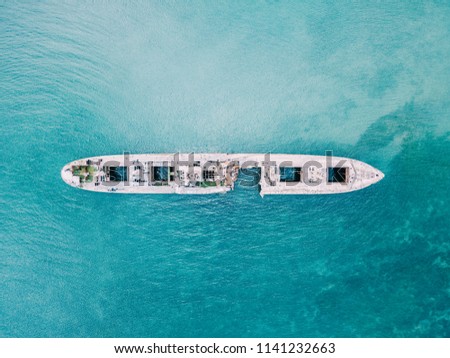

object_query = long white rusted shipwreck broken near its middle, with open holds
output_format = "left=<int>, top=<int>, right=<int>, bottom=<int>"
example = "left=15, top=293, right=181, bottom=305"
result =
left=61, top=153, right=384, bottom=196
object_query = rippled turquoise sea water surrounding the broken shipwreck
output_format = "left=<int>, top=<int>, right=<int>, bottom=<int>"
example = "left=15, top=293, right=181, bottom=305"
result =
left=0, top=1, right=450, bottom=337
